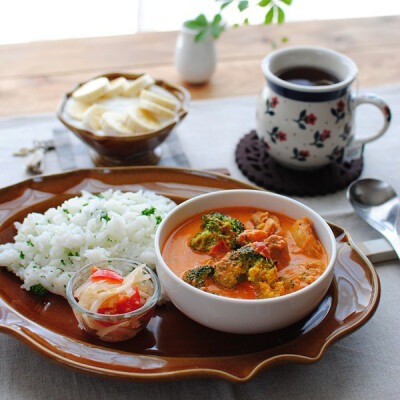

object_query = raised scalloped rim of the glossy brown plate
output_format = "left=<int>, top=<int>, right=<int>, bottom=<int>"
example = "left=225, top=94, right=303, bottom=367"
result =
left=0, top=166, right=381, bottom=382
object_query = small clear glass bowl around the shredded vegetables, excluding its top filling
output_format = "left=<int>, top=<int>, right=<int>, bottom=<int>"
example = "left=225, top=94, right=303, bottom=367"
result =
left=66, top=258, right=160, bottom=342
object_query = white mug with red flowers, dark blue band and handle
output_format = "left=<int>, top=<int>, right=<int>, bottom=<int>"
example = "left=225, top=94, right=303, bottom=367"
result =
left=257, top=46, right=390, bottom=170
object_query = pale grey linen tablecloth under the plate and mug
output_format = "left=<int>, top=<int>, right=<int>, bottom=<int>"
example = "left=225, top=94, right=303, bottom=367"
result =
left=0, top=84, right=400, bottom=400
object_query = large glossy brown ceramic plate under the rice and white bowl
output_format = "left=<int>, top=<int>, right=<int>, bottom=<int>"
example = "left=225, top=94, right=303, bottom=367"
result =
left=0, top=167, right=380, bottom=381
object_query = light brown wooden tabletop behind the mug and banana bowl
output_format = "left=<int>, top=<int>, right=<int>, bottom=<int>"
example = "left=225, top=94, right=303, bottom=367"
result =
left=0, top=16, right=400, bottom=117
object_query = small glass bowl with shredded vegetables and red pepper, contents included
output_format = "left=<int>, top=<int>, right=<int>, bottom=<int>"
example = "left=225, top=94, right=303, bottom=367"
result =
left=66, top=258, right=160, bottom=342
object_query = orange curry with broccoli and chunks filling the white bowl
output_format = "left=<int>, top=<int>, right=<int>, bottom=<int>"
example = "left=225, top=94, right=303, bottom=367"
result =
left=162, top=207, right=328, bottom=299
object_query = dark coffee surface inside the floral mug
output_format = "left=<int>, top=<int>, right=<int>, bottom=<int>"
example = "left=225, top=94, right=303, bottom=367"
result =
left=276, top=67, right=339, bottom=86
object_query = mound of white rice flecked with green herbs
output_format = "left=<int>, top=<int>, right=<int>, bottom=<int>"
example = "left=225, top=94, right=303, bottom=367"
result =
left=0, top=190, right=176, bottom=296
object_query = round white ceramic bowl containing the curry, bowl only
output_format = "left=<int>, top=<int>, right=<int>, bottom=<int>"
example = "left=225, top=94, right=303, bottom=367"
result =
left=155, top=190, right=336, bottom=333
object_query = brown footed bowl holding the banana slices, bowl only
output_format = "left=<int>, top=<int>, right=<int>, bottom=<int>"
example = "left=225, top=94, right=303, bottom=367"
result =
left=57, top=72, right=190, bottom=166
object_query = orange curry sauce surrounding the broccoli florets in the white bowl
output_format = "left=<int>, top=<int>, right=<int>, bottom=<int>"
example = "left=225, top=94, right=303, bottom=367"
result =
left=162, top=207, right=328, bottom=299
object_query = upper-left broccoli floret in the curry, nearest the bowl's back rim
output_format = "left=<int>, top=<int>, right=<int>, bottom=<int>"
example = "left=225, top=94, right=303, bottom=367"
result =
left=190, top=211, right=244, bottom=253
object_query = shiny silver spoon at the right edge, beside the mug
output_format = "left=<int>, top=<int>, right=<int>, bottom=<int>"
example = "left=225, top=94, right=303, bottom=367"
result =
left=347, top=179, right=400, bottom=258
